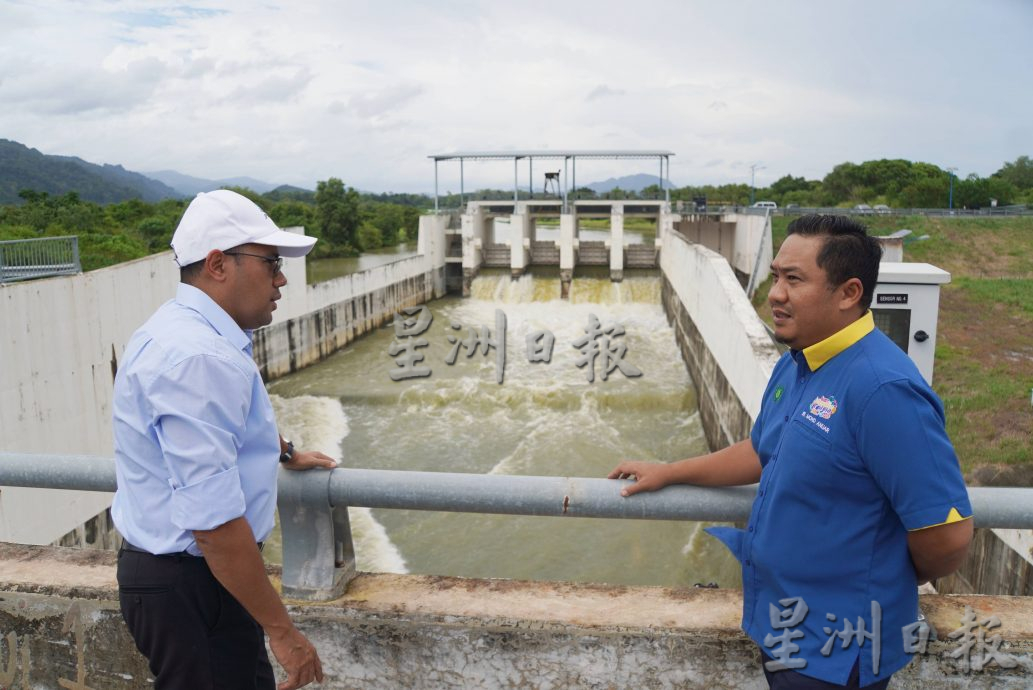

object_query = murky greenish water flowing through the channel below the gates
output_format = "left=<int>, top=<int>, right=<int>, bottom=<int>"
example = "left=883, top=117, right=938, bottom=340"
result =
left=267, top=272, right=740, bottom=587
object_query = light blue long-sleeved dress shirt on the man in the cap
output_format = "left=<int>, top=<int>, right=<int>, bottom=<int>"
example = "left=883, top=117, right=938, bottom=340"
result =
left=112, top=283, right=280, bottom=556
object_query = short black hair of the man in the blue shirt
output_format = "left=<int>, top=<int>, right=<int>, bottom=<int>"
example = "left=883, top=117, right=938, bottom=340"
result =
left=786, top=214, right=882, bottom=311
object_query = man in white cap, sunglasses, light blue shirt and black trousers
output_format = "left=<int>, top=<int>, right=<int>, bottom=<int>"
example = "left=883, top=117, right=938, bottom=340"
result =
left=112, top=190, right=336, bottom=690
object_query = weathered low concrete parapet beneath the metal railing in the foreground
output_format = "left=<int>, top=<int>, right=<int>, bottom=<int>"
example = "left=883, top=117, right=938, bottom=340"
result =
left=0, top=544, right=1033, bottom=690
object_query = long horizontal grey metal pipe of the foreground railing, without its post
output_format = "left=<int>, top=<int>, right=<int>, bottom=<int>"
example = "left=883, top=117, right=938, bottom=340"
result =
left=0, top=452, right=1033, bottom=529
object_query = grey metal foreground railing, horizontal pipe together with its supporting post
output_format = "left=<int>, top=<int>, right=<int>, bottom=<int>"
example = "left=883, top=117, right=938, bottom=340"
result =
left=0, top=452, right=1033, bottom=601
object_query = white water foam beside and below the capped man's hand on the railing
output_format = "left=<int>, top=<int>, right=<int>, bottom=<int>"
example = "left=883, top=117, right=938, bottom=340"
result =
left=270, top=395, right=408, bottom=573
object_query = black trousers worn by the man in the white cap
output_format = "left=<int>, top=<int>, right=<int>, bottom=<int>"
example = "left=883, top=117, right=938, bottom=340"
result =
left=118, top=548, right=276, bottom=690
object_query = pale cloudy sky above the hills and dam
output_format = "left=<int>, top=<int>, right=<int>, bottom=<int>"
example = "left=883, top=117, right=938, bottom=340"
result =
left=0, top=0, right=1033, bottom=192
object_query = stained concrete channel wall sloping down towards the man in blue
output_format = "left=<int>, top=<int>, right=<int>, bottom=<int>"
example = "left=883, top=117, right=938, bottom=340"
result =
left=660, top=232, right=779, bottom=449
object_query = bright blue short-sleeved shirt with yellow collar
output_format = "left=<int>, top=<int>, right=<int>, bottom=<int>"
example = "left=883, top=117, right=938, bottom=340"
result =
left=708, top=312, right=972, bottom=686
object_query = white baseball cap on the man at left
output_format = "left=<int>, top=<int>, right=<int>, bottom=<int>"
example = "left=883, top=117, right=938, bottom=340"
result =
left=171, top=189, right=316, bottom=266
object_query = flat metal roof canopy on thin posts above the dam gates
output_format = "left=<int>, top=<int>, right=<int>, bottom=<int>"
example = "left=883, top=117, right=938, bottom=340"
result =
left=428, top=150, right=675, bottom=211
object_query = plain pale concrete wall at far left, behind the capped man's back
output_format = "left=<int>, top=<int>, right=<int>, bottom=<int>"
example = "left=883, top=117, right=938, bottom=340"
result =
left=0, top=252, right=179, bottom=543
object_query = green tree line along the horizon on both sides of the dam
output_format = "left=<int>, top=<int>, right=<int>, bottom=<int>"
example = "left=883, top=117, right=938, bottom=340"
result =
left=0, top=156, right=1033, bottom=271
